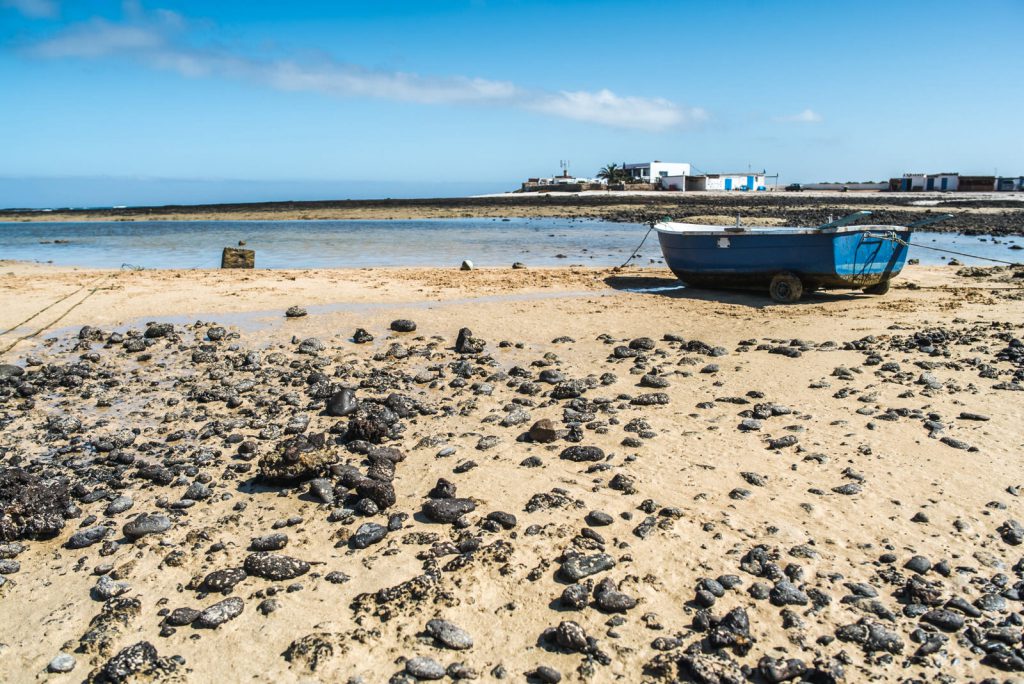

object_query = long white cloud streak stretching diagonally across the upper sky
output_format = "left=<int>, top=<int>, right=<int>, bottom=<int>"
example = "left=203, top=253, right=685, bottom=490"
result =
left=22, top=7, right=704, bottom=131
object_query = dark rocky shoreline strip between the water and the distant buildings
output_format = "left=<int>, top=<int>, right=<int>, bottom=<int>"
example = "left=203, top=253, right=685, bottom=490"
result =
left=6, top=193, right=1024, bottom=237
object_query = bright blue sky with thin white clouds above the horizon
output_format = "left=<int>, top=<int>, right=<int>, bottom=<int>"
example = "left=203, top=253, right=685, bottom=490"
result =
left=0, top=0, right=1024, bottom=206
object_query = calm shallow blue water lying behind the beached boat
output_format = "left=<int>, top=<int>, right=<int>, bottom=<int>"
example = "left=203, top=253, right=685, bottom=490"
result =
left=0, top=218, right=1024, bottom=268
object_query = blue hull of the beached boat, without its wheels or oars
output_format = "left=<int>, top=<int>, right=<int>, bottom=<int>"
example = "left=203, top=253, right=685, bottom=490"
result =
left=657, top=229, right=910, bottom=289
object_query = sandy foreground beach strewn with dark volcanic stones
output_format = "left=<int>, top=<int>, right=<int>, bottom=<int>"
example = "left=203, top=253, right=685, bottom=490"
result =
left=0, top=262, right=1024, bottom=682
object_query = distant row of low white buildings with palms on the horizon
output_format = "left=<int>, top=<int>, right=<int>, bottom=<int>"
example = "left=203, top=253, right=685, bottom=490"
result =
left=518, top=161, right=1024, bottom=193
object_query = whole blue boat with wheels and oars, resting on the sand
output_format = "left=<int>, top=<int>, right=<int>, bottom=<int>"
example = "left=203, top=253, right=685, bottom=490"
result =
left=653, top=211, right=948, bottom=302
